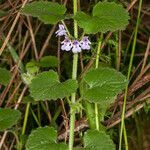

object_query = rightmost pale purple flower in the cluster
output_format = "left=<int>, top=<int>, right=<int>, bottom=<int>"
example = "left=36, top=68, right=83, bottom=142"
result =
left=80, top=36, right=91, bottom=50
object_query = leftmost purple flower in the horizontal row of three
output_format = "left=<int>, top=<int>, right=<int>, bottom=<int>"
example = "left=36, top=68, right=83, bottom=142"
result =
left=61, top=37, right=72, bottom=51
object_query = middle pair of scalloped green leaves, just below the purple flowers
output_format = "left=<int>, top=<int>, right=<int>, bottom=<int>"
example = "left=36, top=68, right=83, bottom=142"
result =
left=29, top=67, right=127, bottom=105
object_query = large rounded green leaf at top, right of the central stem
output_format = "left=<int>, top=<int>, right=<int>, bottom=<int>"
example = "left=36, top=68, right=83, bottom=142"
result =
left=74, top=2, right=129, bottom=33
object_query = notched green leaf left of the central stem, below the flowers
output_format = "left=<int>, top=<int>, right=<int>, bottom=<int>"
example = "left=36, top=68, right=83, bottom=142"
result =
left=29, top=70, right=77, bottom=100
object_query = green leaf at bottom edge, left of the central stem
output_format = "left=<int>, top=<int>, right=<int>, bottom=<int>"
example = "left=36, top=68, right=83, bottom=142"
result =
left=26, top=127, right=67, bottom=150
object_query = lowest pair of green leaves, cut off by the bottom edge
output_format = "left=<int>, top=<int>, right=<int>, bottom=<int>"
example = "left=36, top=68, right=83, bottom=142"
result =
left=26, top=127, right=115, bottom=150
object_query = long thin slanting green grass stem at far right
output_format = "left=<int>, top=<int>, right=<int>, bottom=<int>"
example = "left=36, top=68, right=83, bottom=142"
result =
left=119, top=0, right=142, bottom=150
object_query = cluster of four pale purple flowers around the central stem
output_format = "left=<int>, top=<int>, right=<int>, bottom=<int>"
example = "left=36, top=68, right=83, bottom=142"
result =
left=55, top=24, right=91, bottom=53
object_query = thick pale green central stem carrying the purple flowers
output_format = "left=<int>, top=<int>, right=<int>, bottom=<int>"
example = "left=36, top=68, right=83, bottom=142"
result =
left=69, top=0, right=78, bottom=150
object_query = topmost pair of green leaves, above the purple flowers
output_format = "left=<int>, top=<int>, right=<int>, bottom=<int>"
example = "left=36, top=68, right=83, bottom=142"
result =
left=21, top=1, right=129, bottom=33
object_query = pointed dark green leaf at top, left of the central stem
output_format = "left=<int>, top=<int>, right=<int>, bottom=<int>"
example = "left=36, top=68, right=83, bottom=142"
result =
left=21, top=1, right=66, bottom=24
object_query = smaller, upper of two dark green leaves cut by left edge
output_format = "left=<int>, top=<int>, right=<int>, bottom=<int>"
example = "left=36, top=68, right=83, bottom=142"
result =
left=0, top=68, right=11, bottom=86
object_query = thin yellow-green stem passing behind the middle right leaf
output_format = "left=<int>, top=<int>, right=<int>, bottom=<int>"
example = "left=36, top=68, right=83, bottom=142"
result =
left=95, top=33, right=103, bottom=130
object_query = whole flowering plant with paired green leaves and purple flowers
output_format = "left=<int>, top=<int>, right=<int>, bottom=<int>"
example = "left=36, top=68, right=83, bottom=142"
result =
left=13, top=0, right=129, bottom=150
